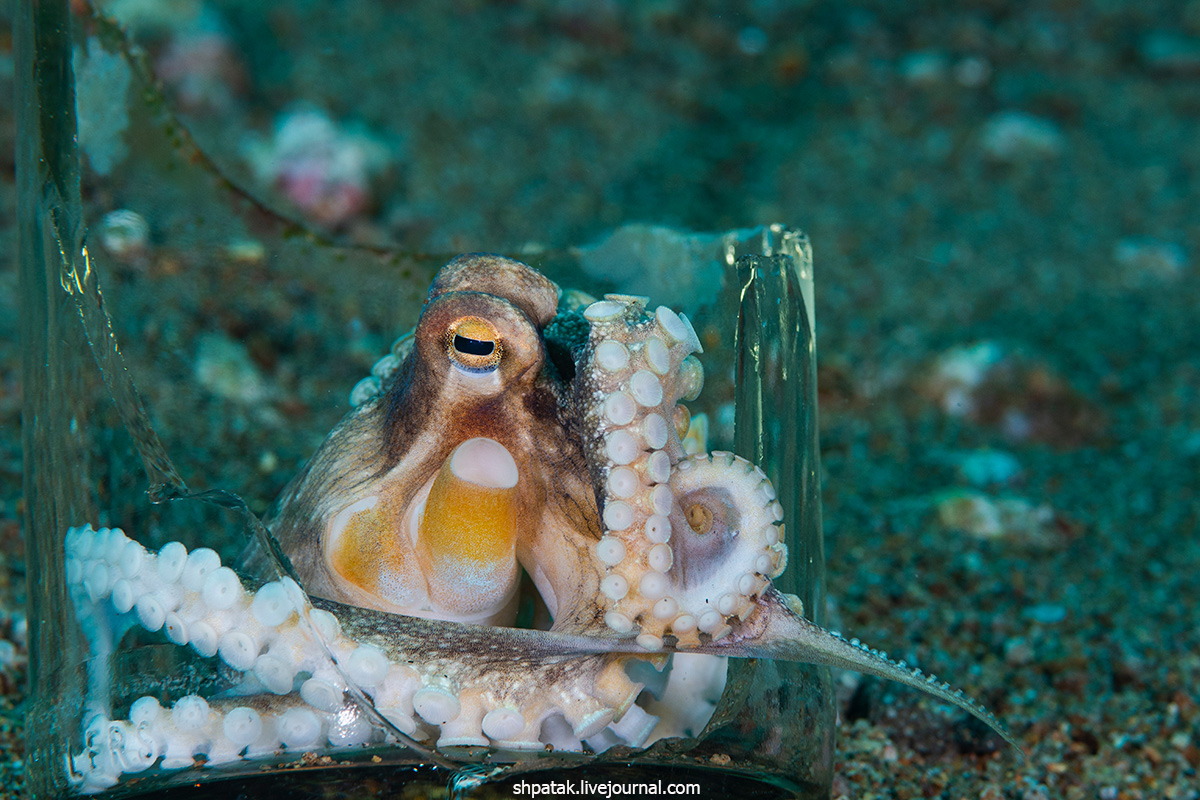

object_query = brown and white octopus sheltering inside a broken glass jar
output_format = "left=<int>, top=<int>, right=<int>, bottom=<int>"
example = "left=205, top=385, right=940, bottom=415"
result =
left=66, top=254, right=1016, bottom=792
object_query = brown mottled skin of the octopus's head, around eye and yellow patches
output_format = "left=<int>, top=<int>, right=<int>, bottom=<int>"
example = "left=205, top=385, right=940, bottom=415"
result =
left=261, top=254, right=600, bottom=630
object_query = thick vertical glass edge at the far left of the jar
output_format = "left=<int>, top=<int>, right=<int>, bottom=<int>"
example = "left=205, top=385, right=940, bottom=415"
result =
left=13, top=0, right=94, bottom=798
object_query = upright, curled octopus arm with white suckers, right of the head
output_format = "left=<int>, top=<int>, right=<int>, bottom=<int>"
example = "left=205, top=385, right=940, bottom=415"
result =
left=580, top=295, right=787, bottom=650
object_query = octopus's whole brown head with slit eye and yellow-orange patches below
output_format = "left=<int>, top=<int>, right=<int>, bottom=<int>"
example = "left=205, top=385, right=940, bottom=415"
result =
left=270, top=255, right=571, bottom=624
